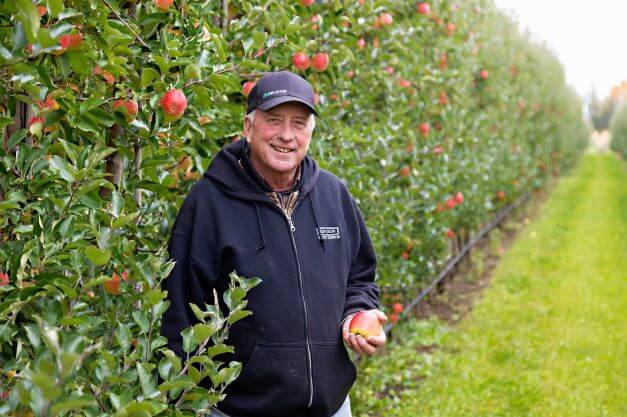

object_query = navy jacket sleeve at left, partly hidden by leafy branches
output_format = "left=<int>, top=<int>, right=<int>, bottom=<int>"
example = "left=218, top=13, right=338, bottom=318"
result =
left=161, top=193, right=215, bottom=359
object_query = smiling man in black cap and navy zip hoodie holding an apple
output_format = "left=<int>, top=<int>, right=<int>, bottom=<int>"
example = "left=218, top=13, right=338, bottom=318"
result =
left=162, top=71, right=387, bottom=417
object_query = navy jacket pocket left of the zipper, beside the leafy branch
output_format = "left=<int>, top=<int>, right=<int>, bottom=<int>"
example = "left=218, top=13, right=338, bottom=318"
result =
left=218, top=342, right=309, bottom=417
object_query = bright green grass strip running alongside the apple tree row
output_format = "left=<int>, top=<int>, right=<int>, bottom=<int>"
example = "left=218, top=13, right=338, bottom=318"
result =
left=351, top=154, right=627, bottom=417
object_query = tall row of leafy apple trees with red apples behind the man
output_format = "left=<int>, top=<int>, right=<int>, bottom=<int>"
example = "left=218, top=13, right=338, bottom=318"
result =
left=0, top=0, right=588, bottom=416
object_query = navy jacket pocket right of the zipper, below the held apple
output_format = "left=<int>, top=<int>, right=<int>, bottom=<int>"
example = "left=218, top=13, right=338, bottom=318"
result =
left=313, top=342, right=357, bottom=415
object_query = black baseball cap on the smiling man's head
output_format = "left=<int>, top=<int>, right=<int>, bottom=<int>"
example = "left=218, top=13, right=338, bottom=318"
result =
left=246, top=71, right=318, bottom=114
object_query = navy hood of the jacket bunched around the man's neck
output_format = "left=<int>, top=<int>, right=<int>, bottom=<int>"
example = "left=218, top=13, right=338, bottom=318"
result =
left=204, top=138, right=320, bottom=202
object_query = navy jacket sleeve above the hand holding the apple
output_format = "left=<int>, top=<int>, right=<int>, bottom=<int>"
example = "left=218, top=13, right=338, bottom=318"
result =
left=343, top=199, right=379, bottom=319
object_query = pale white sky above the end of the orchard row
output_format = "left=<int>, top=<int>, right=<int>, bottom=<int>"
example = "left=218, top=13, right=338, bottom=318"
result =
left=495, top=0, right=627, bottom=99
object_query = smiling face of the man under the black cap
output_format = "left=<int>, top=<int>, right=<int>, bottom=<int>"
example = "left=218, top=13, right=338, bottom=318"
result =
left=244, top=102, right=312, bottom=177
